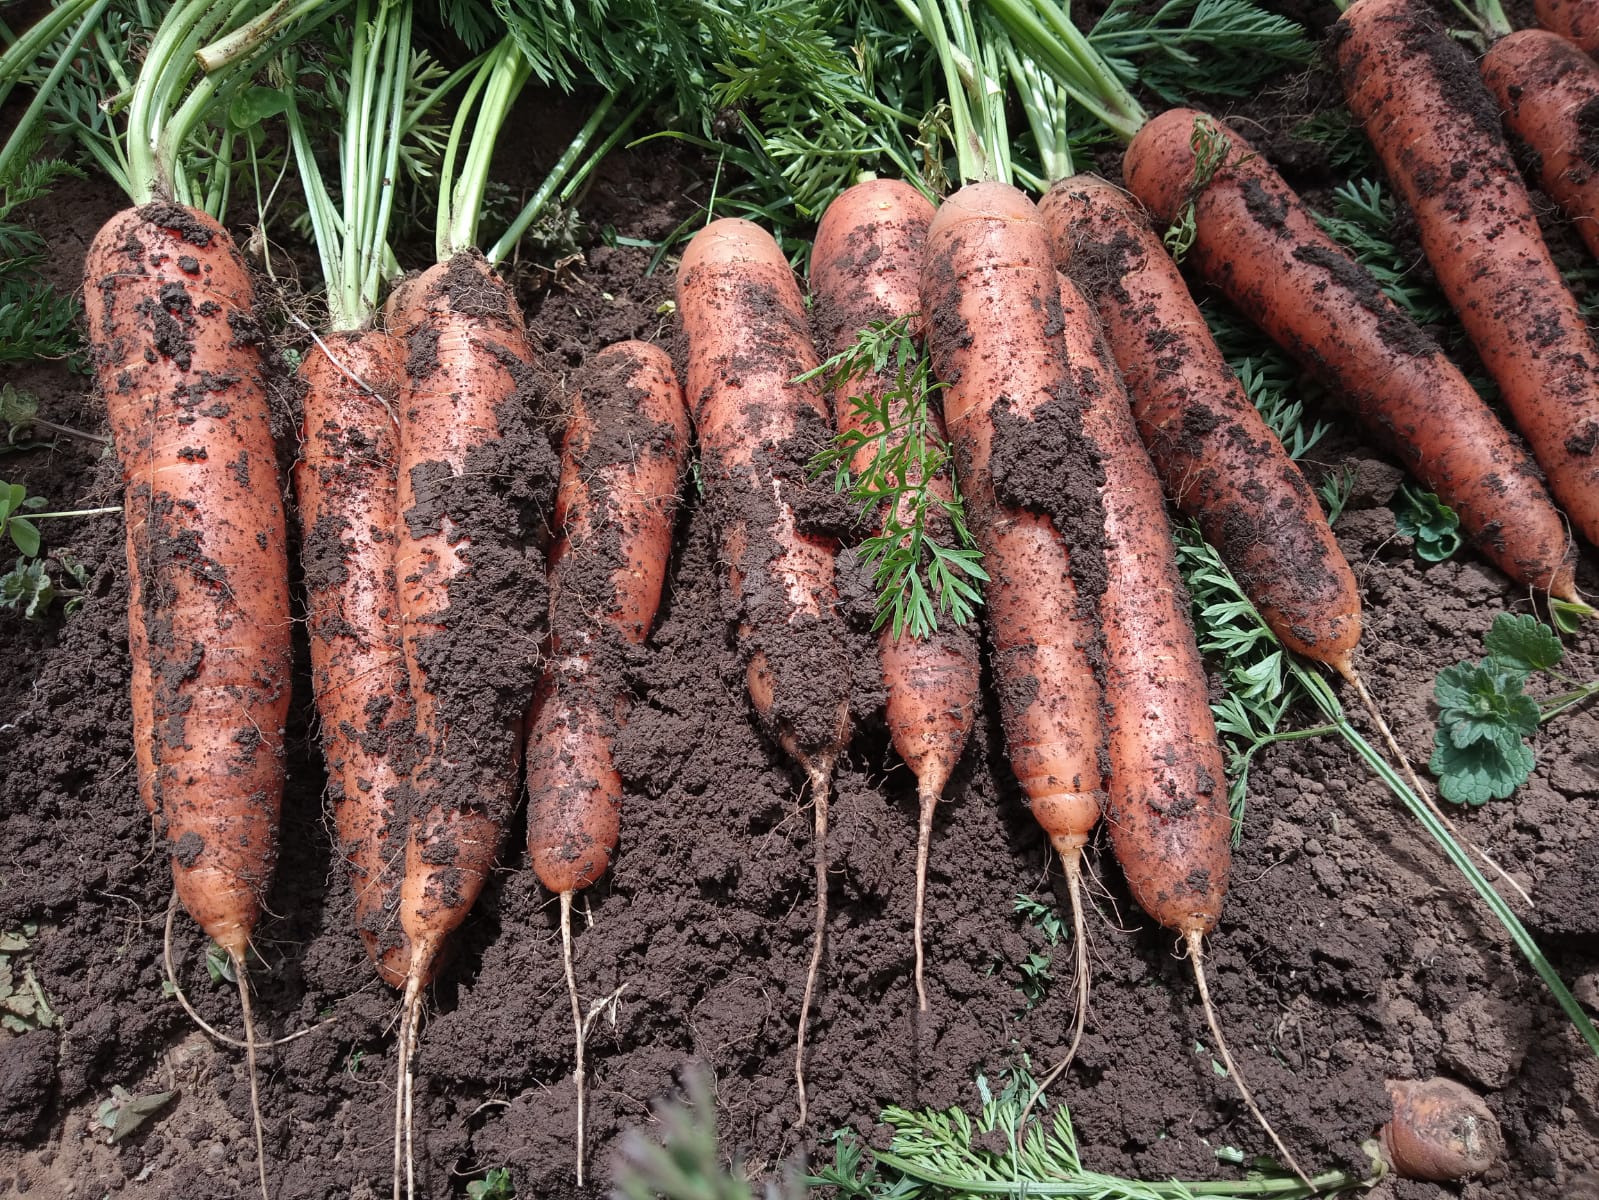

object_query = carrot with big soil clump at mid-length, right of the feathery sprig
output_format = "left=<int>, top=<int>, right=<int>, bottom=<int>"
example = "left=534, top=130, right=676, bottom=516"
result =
left=921, top=182, right=1105, bottom=1081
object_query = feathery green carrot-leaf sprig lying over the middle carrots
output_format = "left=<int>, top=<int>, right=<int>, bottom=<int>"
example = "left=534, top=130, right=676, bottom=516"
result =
left=796, top=317, right=988, bottom=638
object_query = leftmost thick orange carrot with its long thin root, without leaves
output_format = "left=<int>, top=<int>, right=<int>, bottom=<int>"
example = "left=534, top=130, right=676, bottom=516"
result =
left=83, top=202, right=293, bottom=1194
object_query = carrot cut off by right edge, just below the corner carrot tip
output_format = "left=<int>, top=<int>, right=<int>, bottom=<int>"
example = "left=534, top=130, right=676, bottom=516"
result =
left=1481, top=29, right=1599, bottom=265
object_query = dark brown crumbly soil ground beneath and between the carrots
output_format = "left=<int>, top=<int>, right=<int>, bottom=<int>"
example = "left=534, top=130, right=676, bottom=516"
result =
left=0, top=82, right=1599, bottom=1200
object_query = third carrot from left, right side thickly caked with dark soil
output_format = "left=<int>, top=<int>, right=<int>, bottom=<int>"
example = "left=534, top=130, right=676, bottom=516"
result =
left=395, top=251, right=552, bottom=1190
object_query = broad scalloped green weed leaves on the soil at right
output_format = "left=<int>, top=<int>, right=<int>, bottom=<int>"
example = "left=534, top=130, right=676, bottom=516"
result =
left=1428, top=613, right=1599, bottom=805
